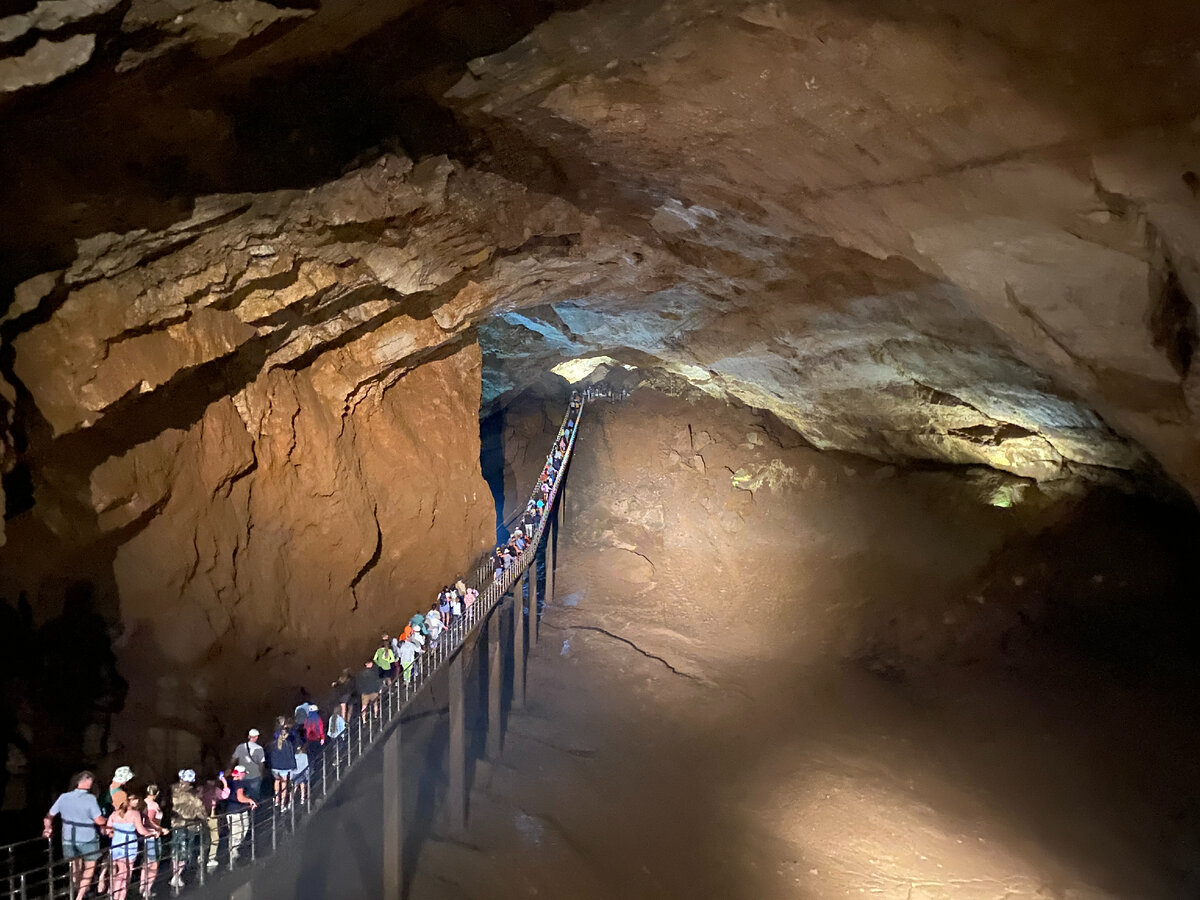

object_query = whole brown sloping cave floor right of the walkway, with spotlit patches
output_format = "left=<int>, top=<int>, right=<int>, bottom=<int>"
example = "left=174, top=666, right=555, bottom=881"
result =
left=410, top=391, right=1200, bottom=900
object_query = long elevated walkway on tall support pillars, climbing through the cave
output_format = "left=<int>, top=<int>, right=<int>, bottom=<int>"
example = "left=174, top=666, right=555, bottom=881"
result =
left=12, top=396, right=584, bottom=900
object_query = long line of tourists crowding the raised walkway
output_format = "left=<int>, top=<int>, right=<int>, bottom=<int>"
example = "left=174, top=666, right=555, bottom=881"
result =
left=42, top=394, right=582, bottom=900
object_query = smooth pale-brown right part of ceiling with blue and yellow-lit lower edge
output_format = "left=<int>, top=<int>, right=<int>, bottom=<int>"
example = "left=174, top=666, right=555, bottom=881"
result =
left=450, top=0, right=1200, bottom=491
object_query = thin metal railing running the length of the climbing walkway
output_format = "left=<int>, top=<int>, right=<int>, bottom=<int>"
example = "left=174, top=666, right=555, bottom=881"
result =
left=12, top=397, right=584, bottom=900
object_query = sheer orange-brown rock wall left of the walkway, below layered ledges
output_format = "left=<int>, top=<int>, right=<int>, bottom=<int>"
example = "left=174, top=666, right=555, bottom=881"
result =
left=4, top=343, right=493, bottom=778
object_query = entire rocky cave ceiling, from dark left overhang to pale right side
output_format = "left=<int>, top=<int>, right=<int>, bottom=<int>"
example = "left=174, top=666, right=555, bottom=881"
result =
left=0, top=0, right=1200, bottom=547
